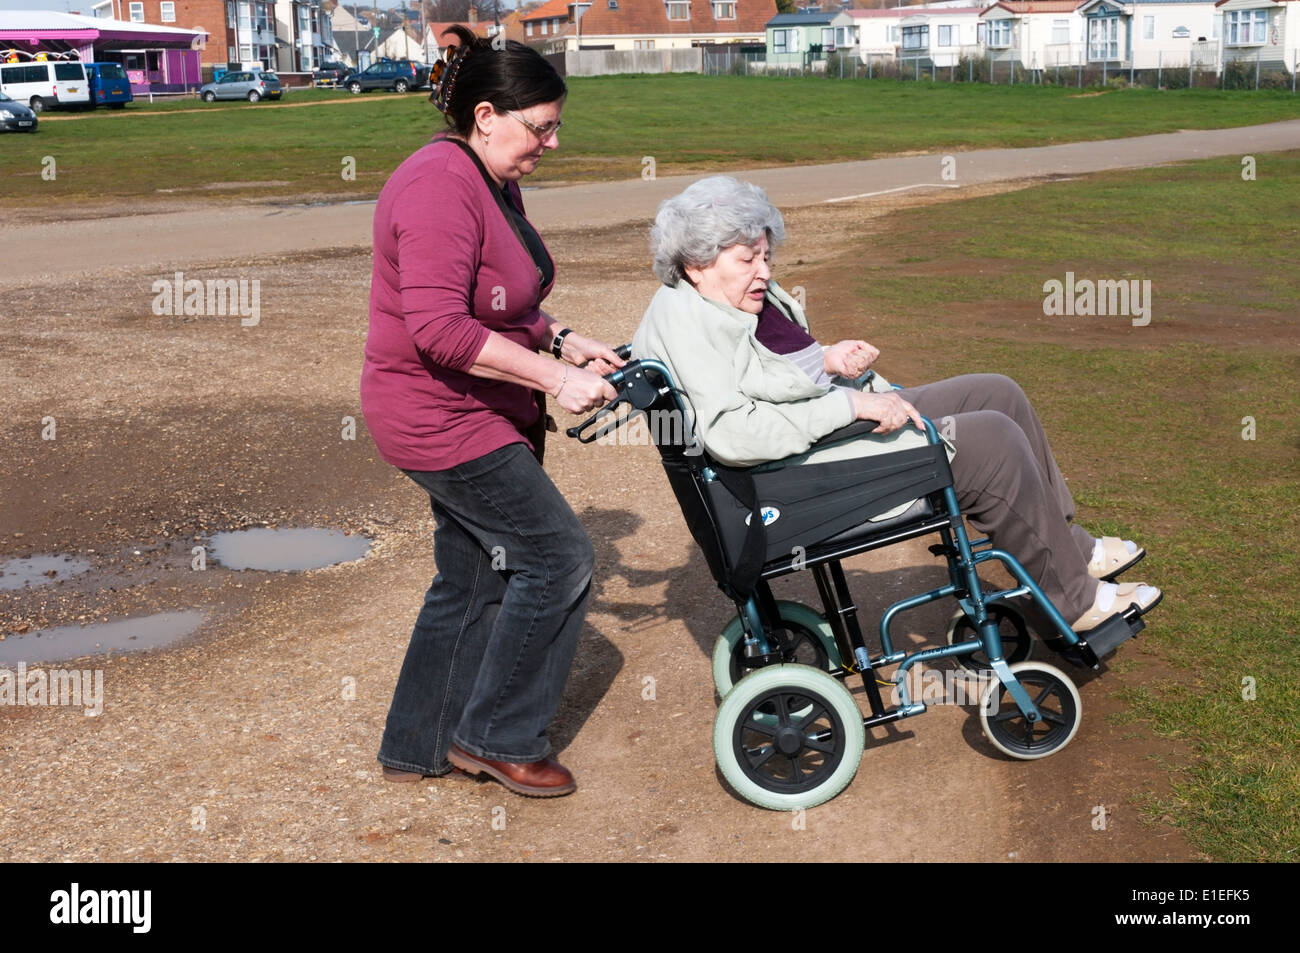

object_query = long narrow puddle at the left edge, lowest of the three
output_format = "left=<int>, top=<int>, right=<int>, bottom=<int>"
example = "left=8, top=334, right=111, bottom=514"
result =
left=0, top=608, right=207, bottom=664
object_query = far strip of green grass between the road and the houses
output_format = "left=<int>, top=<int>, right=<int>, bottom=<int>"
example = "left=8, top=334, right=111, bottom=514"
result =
left=0, top=74, right=1300, bottom=208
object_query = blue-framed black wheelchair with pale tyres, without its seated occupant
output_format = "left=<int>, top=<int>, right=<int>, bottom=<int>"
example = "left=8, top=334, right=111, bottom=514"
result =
left=567, top=346, right=1153, bottom=810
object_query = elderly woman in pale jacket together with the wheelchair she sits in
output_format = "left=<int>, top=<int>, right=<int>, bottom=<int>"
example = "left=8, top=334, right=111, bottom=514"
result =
left=571, top=176, right=1161, bottom=809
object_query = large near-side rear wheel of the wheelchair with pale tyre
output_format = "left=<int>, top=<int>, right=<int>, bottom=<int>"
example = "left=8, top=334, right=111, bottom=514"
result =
left=714, top=664, right=866, bottom=811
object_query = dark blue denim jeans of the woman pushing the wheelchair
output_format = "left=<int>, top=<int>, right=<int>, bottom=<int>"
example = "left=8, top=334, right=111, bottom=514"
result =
left=378, top=443, right=593, bottom=775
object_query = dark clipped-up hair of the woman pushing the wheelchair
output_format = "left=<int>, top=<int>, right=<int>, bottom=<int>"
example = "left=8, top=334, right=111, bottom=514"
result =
left=434, top=23, right=568, bottom=138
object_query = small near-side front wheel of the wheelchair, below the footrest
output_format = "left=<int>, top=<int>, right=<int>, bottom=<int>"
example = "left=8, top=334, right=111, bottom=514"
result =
left=979, top=662, right=1083, bottom=761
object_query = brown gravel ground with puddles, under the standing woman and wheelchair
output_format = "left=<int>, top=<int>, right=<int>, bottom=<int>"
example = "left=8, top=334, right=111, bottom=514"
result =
left=0, top=141, right=1248, bottom=861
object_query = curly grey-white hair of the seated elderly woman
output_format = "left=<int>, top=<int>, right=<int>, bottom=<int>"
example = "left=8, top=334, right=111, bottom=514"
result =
left=650, top=176, right=785, bottom=287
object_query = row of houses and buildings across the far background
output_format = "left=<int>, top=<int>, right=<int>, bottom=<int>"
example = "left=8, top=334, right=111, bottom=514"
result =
left=0, top=0, right=1300, bottom=92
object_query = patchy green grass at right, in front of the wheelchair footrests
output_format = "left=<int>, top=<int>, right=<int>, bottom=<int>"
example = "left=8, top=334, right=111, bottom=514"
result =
left=837, top=153, right=1300, bottom=861
